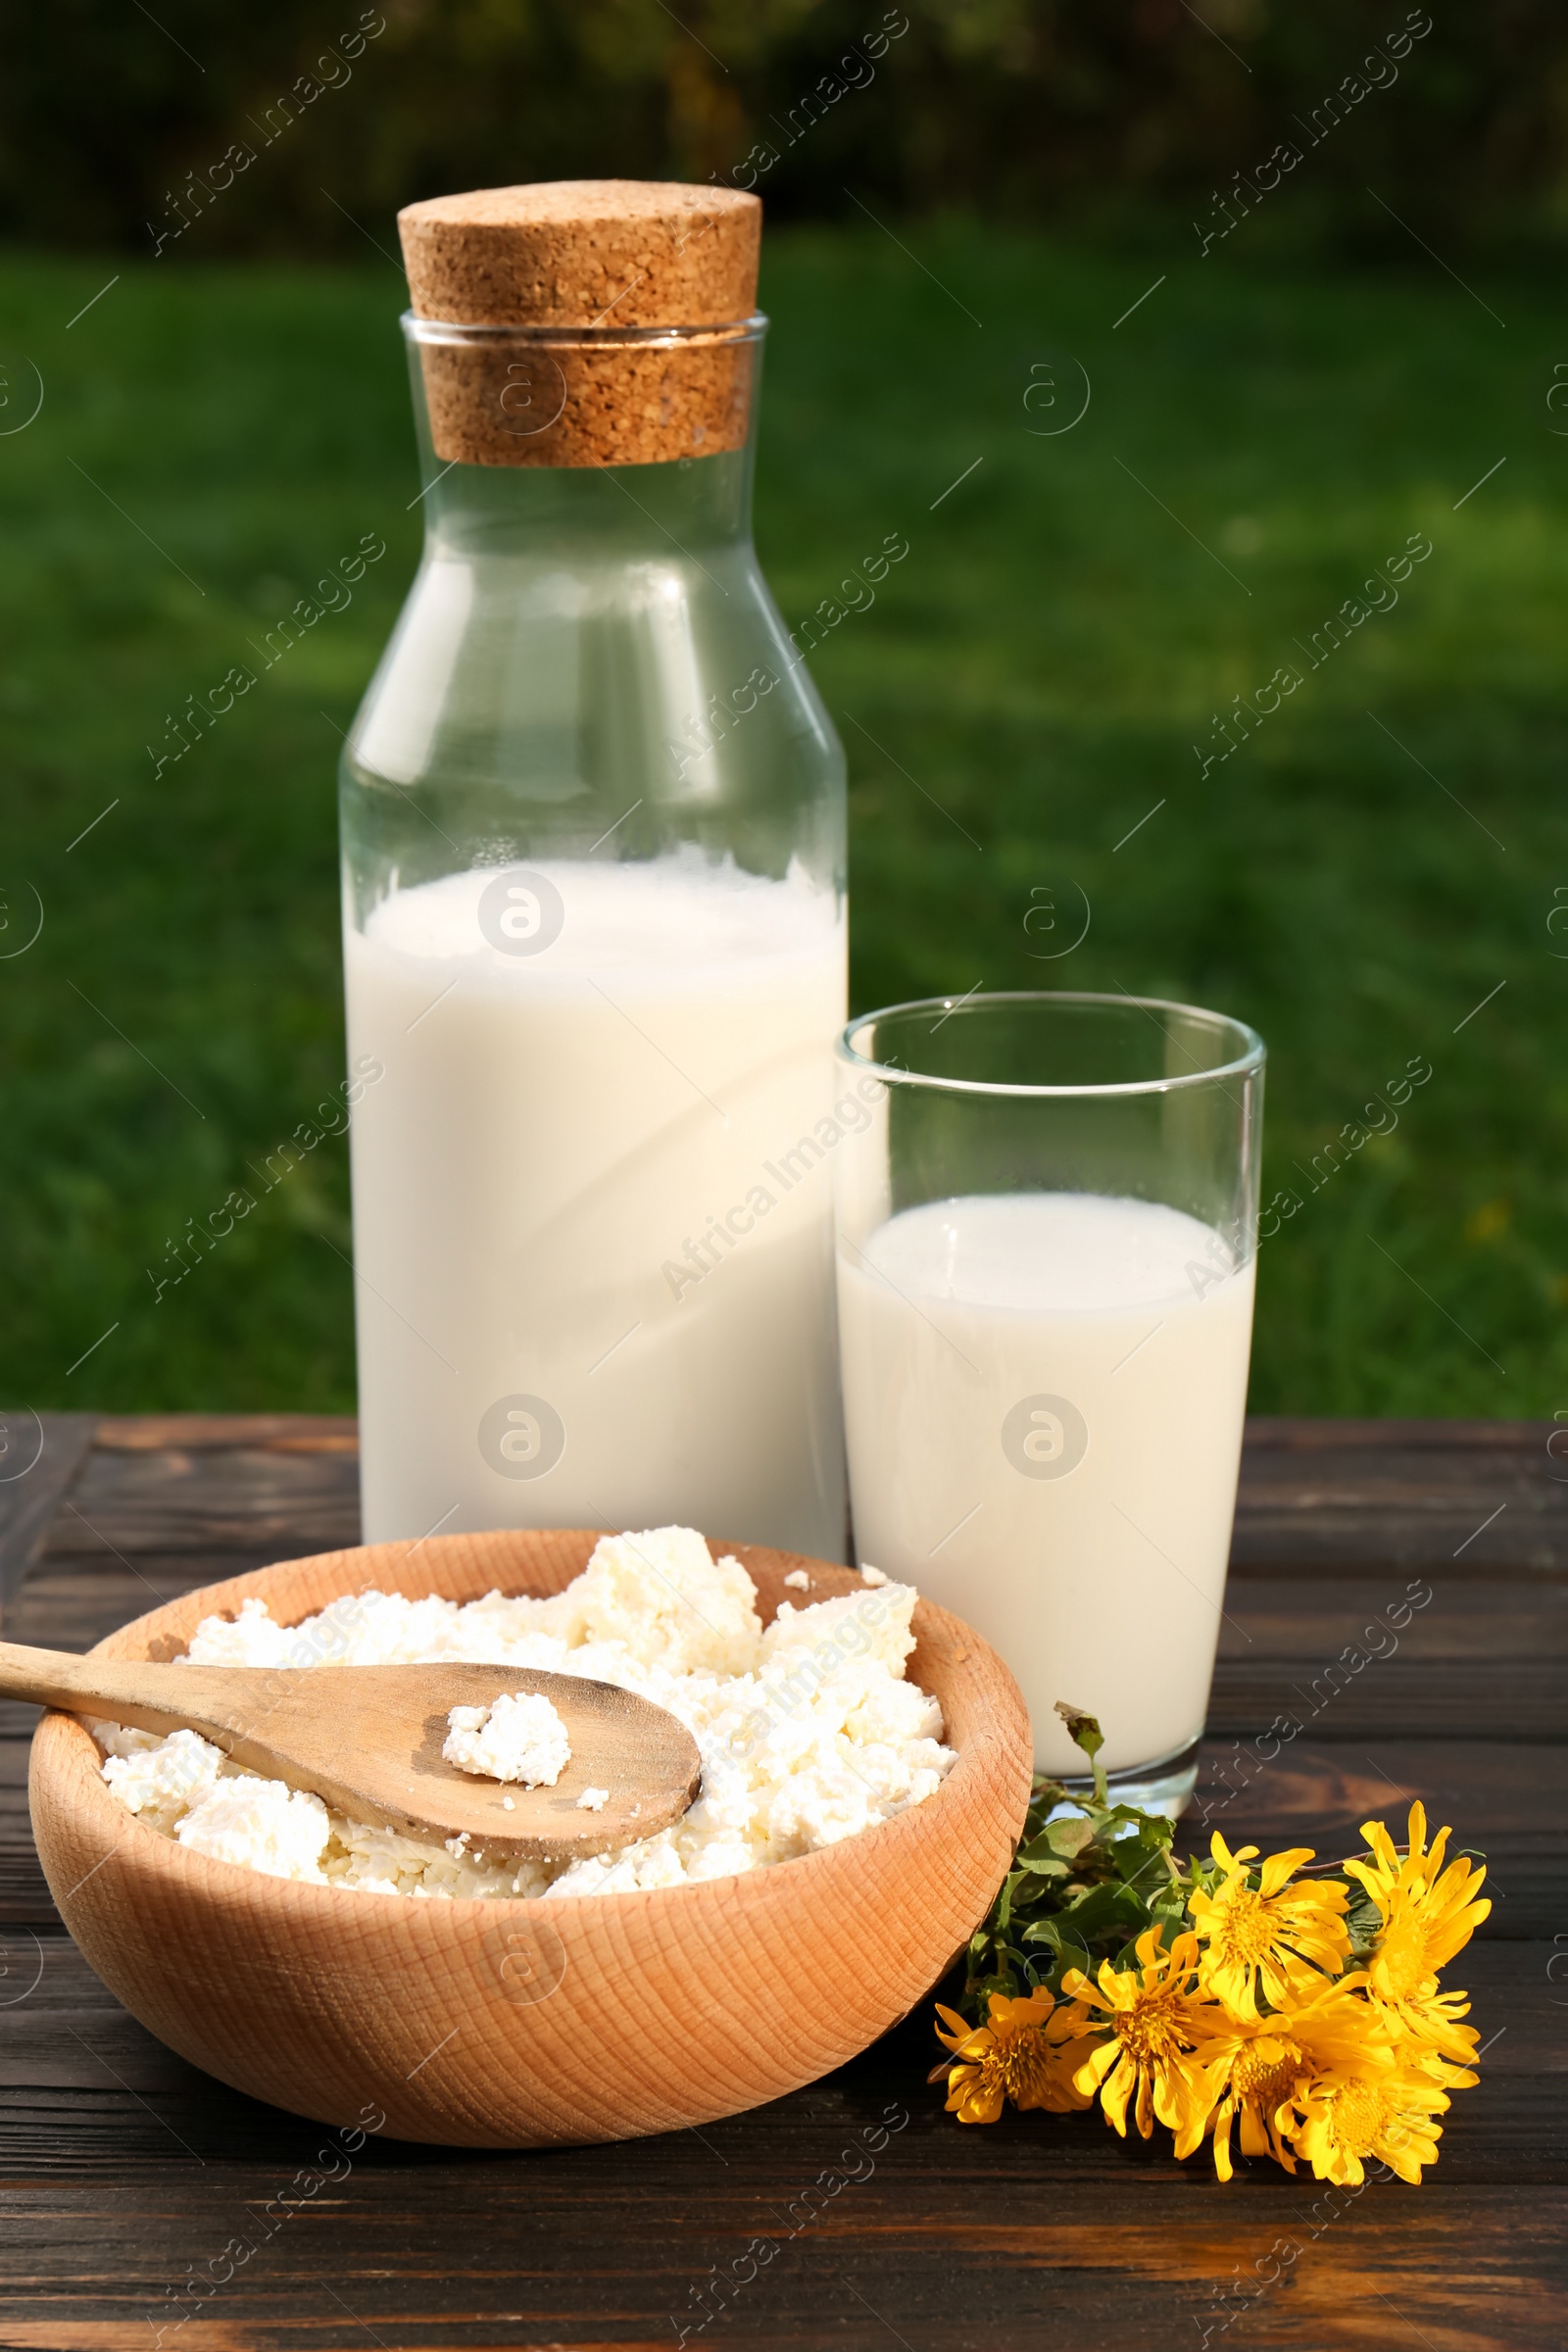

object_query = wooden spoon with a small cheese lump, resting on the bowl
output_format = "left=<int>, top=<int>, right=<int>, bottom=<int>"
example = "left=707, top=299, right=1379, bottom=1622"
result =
left=0, top=1642, right=703, bottom=1860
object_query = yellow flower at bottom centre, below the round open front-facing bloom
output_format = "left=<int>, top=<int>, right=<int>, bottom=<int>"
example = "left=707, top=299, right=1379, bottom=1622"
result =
left=1203, top=1978, right=1394, bottom=2180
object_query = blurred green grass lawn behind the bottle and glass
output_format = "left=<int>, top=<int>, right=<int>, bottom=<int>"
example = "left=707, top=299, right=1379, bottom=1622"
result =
left=0, top=221, right=1568, bottom=1416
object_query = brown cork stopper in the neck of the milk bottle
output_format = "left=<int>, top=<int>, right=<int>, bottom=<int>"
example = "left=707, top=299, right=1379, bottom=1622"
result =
left=397, top=178, right=761, bottom=466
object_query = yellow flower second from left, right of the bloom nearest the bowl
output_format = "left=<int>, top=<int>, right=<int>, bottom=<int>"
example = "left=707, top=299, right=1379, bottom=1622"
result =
left=1062, top=1927, right=1225, bottom=2157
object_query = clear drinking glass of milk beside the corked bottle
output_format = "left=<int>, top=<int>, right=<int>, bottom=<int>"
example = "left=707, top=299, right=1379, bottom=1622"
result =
left=835, top=993, right=1265, bottom=1813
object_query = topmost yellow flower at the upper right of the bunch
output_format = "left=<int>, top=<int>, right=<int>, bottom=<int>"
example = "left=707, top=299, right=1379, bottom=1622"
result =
left=1345, top=1804, right=1491, bottom=2058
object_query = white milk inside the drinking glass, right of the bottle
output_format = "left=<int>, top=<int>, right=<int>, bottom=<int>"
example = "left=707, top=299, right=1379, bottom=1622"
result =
left=839, top=1193, right=1253, bottom=1774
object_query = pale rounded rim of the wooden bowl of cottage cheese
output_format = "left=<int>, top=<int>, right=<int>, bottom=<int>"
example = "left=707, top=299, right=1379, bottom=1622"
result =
left=42, top=1529, right=1034, bottom=1938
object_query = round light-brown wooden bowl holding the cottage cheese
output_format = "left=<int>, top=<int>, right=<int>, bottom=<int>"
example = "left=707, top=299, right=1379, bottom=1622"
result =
left=30, top=1529, right=1032, bottom=2147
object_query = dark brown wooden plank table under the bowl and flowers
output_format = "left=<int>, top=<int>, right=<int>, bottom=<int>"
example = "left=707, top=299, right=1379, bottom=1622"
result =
left=0, top=1416, right=1568, bottom=2352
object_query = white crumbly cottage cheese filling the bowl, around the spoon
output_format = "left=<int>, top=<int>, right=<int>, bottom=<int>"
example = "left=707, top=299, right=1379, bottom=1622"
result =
left=94, top=1527, right=956, bottom=1900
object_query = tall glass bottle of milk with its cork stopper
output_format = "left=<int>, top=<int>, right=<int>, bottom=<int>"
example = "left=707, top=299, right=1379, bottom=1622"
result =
left=341, top=181, right=844, bottom=1557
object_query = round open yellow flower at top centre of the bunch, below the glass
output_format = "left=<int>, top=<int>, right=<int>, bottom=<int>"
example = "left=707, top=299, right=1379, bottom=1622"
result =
left=1187, top=1833, right=1349, bottom=2018
